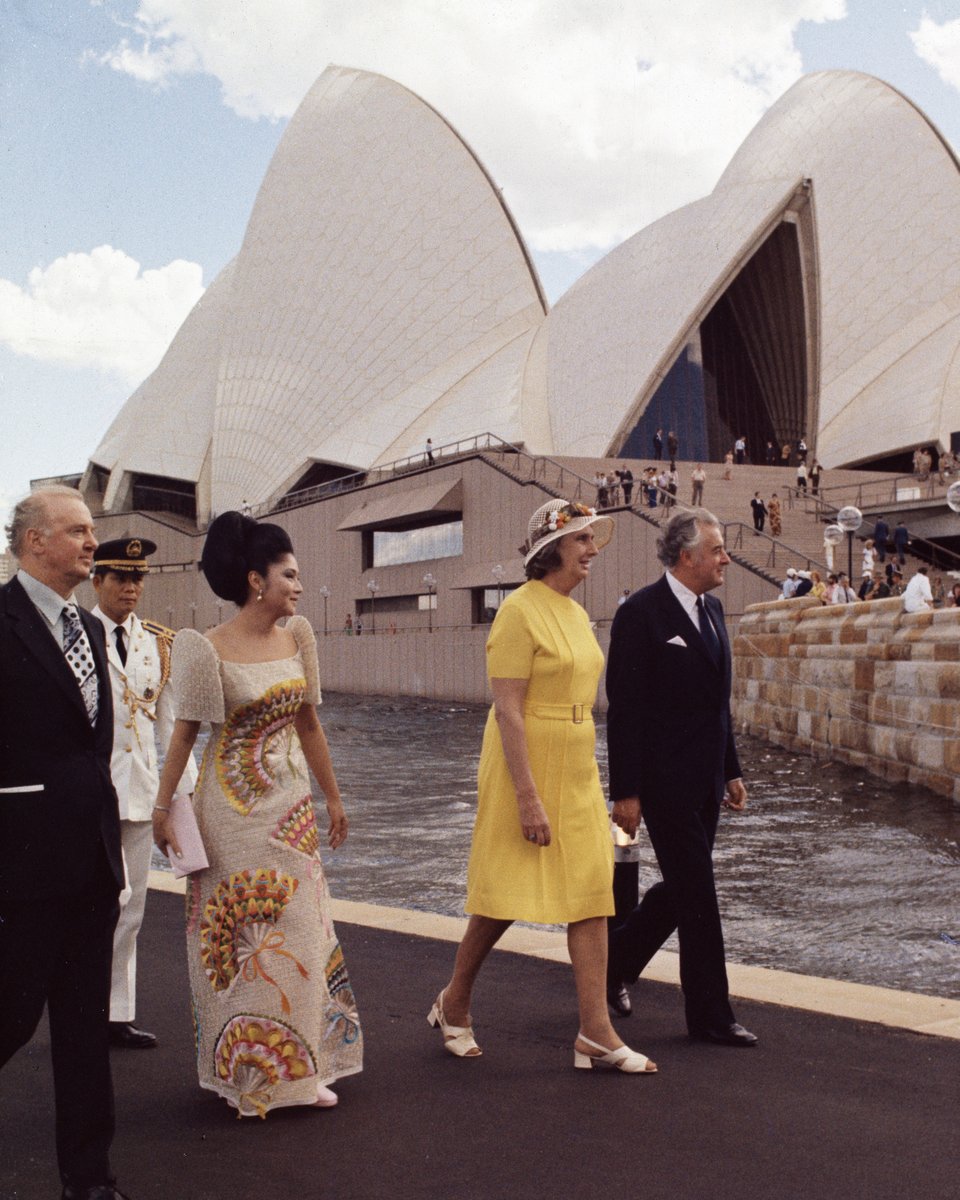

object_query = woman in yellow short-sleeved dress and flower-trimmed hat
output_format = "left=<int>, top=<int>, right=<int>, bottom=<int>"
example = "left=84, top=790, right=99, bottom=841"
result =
left=428, top=499, right=656, bottom=1074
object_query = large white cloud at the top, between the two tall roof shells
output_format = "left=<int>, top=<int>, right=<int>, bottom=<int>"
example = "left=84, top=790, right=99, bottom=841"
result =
left=90, top=0, right=846, bottom=251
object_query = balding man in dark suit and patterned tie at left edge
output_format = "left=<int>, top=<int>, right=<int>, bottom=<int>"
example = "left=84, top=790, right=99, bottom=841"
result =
left=0, top=487, right=124, bottom=1200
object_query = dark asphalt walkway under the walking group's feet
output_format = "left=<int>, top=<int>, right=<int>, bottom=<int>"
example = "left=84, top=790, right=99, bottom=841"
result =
left=0, top=893, right=960, bottom=1200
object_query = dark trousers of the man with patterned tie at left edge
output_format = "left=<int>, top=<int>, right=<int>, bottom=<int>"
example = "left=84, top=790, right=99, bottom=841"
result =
left=0, top=860, right=120, bottom=1188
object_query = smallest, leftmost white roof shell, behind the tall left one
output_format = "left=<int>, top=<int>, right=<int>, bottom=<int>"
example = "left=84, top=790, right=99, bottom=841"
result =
left=90, top=263, right=234, bottom=510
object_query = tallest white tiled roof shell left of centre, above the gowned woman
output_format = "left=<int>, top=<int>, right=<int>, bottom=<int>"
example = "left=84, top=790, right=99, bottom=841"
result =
left=212, top=67, right=545, bottom=510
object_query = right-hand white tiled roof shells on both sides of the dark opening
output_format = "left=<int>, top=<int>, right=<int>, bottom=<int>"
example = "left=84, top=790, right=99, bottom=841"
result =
left=538, top=71, right=960, bottom=466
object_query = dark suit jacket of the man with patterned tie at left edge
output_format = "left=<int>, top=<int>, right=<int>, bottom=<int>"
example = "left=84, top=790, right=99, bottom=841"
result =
left=0, top=578, right=124, bottom=906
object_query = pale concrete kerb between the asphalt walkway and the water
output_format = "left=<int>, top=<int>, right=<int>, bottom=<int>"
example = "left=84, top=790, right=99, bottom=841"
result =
left=150, top=871, right=960, bottom=1040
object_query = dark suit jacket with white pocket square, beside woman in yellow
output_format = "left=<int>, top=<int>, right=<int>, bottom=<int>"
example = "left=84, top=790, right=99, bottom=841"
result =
left=607, top=578, right=740, bottom=804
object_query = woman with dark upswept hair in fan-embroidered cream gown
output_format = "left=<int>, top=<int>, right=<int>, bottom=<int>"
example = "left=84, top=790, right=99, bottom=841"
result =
left=154, top=512, right=362, bottom=1116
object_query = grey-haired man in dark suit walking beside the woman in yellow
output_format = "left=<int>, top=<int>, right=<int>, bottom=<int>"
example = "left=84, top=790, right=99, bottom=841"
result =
left=607, top=509, right=757, bottom=1046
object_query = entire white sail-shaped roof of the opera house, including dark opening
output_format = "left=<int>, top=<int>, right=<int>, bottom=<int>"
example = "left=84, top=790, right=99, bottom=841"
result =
left=85, top=67, right=960, bottom=521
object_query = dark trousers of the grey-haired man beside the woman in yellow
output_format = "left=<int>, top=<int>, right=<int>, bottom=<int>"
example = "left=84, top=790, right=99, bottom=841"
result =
left=610, top=797, right=734, bottom=1033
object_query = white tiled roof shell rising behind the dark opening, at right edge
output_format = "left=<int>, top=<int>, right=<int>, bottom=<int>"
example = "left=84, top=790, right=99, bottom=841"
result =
left=714, top=71, right=960, bottom=466
